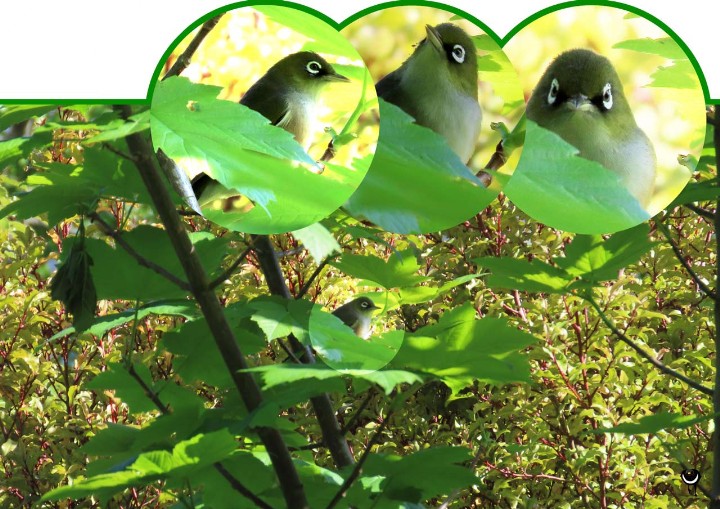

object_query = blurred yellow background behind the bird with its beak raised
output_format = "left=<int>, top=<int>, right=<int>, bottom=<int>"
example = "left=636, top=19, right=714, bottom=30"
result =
left=342, top=6, right=524, bottom=187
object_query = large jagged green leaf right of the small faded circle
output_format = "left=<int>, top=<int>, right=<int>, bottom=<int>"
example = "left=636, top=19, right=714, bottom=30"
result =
left=391, top=304, right=537, bottom=394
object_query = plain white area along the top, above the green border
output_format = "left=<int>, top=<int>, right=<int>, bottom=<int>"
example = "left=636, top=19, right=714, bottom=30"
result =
left=0, top=0, right=720, bottom=100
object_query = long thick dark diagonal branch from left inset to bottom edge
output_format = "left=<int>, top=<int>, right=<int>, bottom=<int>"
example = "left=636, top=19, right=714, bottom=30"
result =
left=115, top=106, right=308, bottom=509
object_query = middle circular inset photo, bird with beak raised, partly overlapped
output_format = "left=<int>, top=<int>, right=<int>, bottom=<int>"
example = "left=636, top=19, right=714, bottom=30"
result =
left=342, top=6, right=525, bottom=233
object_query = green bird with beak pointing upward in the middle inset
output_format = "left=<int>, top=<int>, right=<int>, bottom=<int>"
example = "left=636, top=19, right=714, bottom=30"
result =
left=375, top=23, right=482, bottom=163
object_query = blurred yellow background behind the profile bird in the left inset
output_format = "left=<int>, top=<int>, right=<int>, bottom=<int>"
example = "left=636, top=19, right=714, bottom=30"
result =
left=164, top=7, right=379, bottom=166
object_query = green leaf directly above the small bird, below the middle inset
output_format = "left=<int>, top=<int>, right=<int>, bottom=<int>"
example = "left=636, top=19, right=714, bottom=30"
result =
left=330, top=251, right=429, bottom=289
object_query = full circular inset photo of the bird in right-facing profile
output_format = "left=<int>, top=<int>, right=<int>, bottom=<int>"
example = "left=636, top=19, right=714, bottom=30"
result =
left=150, top=5, right=379, bottom=234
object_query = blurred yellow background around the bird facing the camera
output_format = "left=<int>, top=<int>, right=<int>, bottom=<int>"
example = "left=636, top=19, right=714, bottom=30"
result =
left=504, top=6, right=706, bottom=215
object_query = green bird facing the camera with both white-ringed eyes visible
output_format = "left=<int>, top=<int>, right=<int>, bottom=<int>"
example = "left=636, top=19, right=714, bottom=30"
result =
left=527, top=49, right=657, bottom=207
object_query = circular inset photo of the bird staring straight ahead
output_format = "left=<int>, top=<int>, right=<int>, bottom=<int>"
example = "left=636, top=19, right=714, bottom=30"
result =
left=504, top=6, right=705, bottom=234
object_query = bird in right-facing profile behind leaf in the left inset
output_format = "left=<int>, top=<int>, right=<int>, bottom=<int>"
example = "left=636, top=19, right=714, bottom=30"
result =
left=192, top=51, right=350, bottom=205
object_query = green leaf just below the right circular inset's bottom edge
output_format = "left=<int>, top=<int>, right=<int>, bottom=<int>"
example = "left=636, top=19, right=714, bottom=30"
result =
left=554, top=223, right=657, bottom=282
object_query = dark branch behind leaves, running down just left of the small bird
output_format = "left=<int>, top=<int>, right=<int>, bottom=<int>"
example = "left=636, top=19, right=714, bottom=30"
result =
left=252, top=235, right=355, bottom=468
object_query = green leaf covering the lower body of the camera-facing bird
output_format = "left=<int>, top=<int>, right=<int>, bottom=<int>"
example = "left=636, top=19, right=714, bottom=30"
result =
left=505, top=121, right=650, bottom=234
